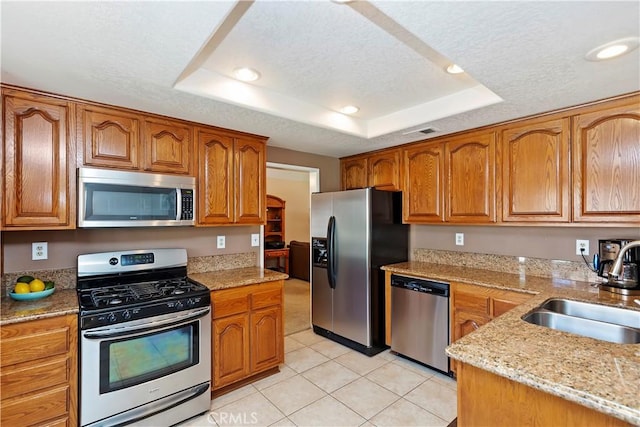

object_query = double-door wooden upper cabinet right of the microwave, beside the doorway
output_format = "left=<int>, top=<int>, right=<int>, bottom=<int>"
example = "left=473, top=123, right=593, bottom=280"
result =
left=197, top=128, right=266, bottom=225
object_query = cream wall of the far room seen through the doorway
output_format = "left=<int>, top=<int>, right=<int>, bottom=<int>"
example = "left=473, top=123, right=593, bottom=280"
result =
left=267, top=169, right=311, bottom=243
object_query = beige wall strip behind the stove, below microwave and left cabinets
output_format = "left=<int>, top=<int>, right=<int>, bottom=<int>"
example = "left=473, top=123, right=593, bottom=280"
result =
left=2, top=226, right=260, bottom=273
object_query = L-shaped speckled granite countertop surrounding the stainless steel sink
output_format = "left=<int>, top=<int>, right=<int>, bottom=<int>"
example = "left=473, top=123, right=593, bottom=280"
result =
left=382, top=262, right=640, bottom=425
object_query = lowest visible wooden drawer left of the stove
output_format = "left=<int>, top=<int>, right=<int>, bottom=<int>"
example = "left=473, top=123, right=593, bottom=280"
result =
left=0, top=386, right=70, bottom=426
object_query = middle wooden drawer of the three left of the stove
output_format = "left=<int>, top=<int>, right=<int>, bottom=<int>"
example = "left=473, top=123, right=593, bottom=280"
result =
left=0, top=356, right=70, bottom=399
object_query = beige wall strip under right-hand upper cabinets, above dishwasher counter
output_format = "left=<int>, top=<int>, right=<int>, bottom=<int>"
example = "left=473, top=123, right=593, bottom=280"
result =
left=409, top=225, right=640, bottom=261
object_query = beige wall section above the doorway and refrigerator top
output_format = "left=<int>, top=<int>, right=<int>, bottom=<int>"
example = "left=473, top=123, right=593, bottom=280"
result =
left=267, top=145, right=340, bottom=193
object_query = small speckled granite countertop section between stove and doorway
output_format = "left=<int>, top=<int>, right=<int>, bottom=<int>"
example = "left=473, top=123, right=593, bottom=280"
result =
left=189, top=267, right=289, bottom=291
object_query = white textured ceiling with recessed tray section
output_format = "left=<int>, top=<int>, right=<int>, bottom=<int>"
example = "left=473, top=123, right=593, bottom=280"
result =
left=0, top=0, right=640, bottom=157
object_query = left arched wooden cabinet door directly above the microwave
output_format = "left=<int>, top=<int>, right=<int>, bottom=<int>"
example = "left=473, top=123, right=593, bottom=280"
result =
left=78, top=104, right=141, bottom=169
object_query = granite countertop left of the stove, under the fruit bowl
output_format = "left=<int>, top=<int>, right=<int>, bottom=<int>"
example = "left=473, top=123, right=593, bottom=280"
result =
left=0, top=288, right=78, bottom=326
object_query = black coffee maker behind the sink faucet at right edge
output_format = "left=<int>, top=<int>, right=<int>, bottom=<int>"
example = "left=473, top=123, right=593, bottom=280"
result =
left=597, top=239, right=640, bottom=288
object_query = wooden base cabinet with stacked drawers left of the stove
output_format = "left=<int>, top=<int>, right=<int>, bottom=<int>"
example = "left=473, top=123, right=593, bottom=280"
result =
left=0, top=315, right=78, bottom=427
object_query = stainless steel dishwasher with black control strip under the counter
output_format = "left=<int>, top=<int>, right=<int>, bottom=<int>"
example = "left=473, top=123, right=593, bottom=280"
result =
left=391, top=274, right=450, bottom=375
